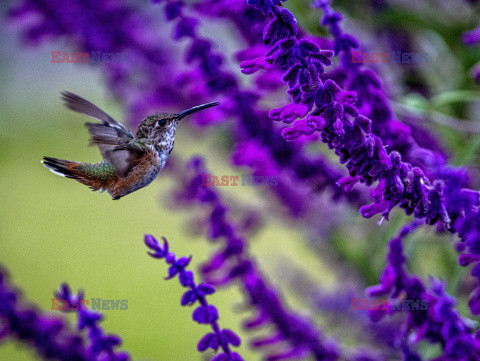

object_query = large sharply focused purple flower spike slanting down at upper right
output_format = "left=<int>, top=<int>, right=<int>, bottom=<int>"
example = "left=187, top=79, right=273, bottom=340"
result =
left=241, top=0, right=450, bottom=228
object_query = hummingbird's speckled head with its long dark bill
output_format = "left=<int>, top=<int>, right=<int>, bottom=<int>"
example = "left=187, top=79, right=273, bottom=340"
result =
left=137, top=102, right=218, bottom=153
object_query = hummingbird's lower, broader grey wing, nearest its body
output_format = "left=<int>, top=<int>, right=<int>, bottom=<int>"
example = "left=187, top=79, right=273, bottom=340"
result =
left=85, top=123, right=148, bottom=177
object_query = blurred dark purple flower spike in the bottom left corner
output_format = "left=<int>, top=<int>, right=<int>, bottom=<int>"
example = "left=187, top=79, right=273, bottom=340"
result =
left=0, top=268, right=94, bottom=361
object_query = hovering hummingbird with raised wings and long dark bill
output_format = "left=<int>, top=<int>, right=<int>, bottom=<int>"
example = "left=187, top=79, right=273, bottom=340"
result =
left=42, top=92, right=218, bottom=199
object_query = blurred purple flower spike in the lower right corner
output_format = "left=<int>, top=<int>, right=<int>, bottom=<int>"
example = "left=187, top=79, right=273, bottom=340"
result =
left=367, top=221, right=480, bottom=361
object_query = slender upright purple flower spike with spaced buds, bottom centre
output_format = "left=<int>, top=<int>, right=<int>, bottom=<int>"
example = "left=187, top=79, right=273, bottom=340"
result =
left=145, top=234, right=243, bottom=361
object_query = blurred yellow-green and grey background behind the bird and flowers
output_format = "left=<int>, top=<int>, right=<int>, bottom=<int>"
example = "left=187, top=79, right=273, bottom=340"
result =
left=0, top=0, right=480, bottom=361
